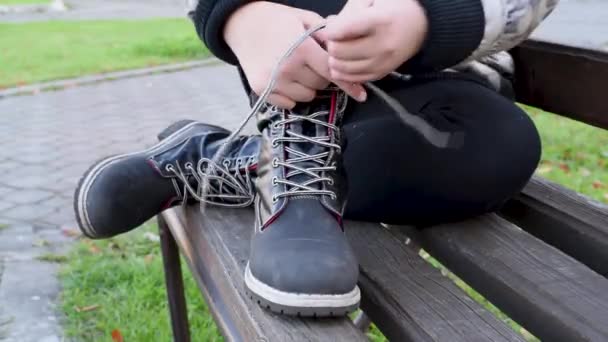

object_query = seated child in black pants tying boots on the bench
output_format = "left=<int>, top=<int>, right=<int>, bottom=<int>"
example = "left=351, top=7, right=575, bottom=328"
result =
left=75, top=0, right=557, bottom=316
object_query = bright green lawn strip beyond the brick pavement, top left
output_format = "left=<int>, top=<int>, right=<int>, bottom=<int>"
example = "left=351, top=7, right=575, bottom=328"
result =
left=0, top=19, right=208, bottom=88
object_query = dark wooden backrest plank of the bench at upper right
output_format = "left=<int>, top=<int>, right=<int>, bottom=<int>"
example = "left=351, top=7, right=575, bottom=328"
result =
left=511, top=40, right=608, bottom=129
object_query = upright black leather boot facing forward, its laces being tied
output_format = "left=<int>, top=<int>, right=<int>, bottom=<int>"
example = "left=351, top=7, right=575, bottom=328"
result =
left=245, top=91, right=360, bottom=316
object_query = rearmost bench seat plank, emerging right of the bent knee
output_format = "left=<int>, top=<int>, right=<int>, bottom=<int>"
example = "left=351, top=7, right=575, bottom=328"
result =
left=501, top=177, right=608, bottom=277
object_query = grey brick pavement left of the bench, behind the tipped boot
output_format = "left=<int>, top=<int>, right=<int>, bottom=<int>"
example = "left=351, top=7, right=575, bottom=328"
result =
left=0, top=65, right=252, bottom=342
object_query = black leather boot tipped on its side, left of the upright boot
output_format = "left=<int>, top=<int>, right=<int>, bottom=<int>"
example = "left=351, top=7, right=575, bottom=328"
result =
left=74, top=121, right=261, bottom=239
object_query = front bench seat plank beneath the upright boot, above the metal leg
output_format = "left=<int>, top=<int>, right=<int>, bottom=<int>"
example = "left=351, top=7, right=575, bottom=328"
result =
left=162, top=206, right=367, bottom=341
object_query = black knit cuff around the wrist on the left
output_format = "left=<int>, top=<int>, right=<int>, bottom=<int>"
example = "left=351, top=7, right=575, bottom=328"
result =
left=192, top=0, right=250, bottom=65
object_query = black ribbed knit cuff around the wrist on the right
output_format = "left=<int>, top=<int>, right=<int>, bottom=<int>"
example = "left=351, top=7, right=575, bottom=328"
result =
left=398, top=0, right=485, bottom=73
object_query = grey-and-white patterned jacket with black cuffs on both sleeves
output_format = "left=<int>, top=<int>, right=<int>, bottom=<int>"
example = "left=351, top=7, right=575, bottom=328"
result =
left=189, top=0, right=558, bottom=95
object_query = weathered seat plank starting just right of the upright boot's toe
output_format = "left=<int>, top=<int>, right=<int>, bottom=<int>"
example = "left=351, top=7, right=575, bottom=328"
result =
left=346, top=222, right=523, bottom=342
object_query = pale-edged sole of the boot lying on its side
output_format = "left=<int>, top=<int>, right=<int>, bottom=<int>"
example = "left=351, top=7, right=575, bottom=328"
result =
left=74, top=121, right=201, bottom=239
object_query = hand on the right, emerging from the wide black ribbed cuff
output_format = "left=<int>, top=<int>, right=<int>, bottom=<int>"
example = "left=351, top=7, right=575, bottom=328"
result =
left=318, top=0, right=428, bottom=82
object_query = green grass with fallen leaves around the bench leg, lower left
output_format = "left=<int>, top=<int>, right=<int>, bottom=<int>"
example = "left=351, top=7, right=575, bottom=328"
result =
left=60, top=226, right=222, bottom=342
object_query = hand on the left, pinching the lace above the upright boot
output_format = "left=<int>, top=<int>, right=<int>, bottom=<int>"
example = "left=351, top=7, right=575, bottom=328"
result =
left=224, top=1, right=366, bottom=109
